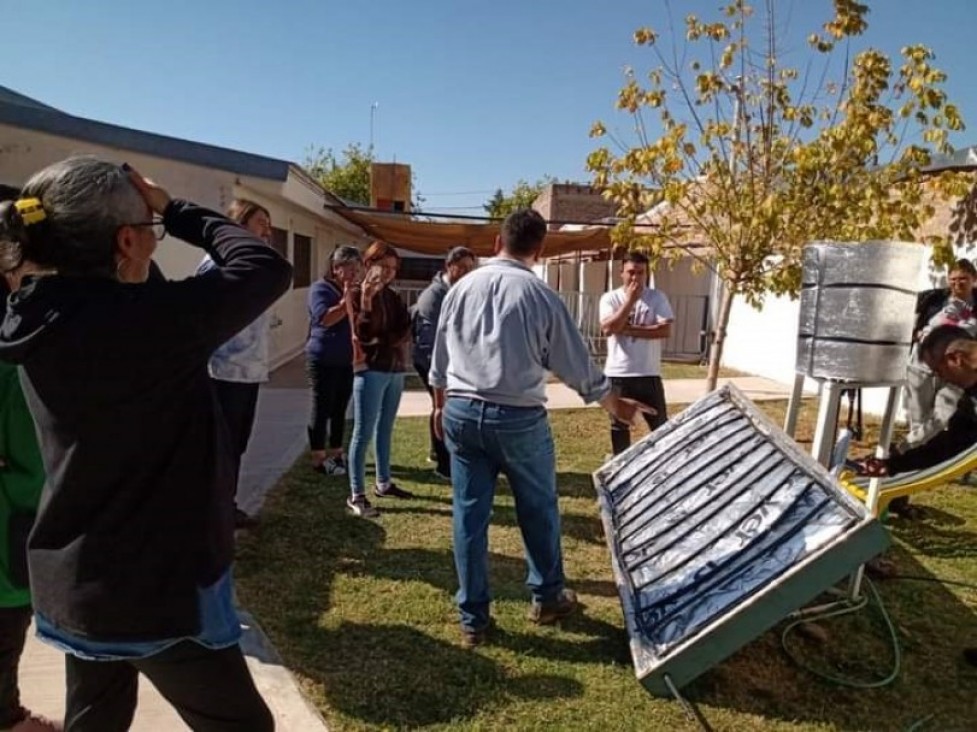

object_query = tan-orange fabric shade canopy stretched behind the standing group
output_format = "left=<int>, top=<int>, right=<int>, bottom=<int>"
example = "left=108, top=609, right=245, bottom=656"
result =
left=331, top=206, right=613, bottom=257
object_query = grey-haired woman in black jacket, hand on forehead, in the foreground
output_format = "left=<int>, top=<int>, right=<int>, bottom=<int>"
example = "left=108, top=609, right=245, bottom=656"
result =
left=0, top=158, right=292, bottom=732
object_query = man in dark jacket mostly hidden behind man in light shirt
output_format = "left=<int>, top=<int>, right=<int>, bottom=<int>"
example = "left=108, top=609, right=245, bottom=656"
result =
left=413, top=247, right=476, bottom=480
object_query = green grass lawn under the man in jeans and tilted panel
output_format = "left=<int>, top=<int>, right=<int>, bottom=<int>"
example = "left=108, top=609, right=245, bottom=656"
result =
left=236, top=403, right=977, bottom=732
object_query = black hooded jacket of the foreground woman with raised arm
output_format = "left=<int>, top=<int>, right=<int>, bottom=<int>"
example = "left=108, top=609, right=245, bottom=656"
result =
left=0, top=201, right=292, bottom=641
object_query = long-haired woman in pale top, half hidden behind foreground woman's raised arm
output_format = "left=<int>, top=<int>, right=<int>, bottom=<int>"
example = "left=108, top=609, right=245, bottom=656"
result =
left=197, top=198, right=271, bottom=529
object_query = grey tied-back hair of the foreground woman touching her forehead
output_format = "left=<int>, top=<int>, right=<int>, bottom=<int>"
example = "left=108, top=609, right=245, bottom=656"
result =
left=0, top=157, right=149, bottom=276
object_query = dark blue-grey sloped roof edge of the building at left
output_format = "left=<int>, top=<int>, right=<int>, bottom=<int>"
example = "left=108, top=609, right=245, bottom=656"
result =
left=0, top=86, right=291, bottom=181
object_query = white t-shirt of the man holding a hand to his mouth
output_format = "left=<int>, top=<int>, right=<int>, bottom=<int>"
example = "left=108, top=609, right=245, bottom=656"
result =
left=599, top=287, right=675, bottom=377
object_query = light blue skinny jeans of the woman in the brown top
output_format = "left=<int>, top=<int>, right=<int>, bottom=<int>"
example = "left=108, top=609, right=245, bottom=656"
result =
left=349, top=371, right=404, bottom=496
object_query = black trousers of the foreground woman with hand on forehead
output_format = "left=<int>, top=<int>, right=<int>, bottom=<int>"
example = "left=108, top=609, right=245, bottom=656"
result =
left=64, top=640, right=275, bottom=732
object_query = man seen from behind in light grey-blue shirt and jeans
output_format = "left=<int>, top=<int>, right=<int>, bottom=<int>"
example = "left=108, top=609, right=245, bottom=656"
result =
left=429, top=210, right=650, bottom=647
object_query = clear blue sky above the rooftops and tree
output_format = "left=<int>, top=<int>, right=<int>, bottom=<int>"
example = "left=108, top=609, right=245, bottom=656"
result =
left=0, top=0, right=977, bottom=214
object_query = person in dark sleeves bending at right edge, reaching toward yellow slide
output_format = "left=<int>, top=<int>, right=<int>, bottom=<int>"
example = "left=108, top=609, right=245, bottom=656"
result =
left=860, top=325, right=977, bottom=477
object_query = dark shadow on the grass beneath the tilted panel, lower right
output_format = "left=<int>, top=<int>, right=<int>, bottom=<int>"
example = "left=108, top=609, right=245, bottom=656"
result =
left=684, top=547, right=977, bottom=730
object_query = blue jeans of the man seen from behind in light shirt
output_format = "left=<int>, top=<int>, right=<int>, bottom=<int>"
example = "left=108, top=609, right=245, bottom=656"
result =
left=443, top=397, right=564, bottom=630
